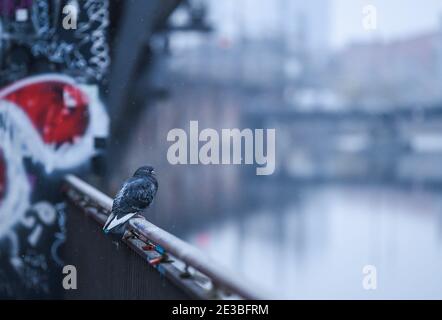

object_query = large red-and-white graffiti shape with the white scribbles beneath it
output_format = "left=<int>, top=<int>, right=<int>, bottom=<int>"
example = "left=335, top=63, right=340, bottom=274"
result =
left=0, top=74, right=108, bottom=296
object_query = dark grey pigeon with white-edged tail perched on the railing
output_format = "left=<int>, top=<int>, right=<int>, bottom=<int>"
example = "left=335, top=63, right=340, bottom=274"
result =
left=103, top=166, right=158, bottom=233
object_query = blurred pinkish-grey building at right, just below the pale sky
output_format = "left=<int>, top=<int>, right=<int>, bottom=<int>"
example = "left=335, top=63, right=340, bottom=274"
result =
left=327, top=27, right=442, bottom=110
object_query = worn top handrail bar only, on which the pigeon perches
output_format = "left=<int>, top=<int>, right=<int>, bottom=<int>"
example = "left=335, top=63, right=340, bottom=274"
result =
left=65, top=174, right=264, bottom=299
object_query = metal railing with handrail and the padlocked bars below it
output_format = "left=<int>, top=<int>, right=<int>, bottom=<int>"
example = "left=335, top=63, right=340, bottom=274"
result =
left=65, top=175, right=264, bottom=299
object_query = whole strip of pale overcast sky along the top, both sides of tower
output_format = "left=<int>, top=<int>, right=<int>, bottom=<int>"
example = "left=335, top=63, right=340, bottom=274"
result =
left=208, top=0, right=442, bottom=49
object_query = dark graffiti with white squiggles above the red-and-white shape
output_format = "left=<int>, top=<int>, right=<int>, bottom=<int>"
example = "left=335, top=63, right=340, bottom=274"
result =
left=0, top=0, right=110, bottom=84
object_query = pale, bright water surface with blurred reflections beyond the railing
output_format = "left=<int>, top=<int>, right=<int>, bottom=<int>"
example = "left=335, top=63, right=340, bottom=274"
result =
left=185, top=184, right=442, bottom=299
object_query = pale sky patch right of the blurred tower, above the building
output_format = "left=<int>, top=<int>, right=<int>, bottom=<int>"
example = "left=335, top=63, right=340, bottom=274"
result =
left=330, top=0, right=442, bottom=47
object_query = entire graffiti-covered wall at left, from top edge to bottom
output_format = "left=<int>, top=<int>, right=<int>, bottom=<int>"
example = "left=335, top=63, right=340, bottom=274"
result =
left=0, top=0, right=110, bottom=297
